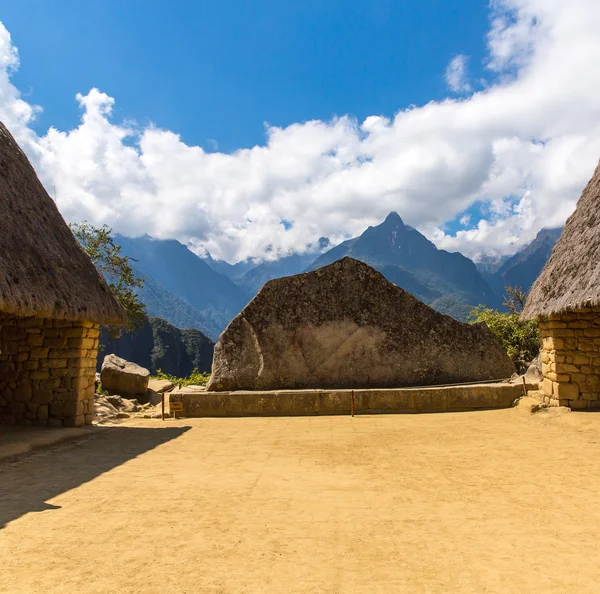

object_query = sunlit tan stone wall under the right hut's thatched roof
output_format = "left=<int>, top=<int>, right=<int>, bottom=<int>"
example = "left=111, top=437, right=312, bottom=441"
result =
left=539, top=308, right=600, bottom=409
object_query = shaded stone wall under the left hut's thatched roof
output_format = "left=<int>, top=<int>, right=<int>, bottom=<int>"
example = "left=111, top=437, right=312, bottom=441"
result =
left=0, top=314, right=99, bottom=427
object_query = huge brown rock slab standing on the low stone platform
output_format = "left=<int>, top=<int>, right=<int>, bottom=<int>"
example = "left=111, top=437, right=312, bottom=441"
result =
left=208, top=258, right=515, bottom=391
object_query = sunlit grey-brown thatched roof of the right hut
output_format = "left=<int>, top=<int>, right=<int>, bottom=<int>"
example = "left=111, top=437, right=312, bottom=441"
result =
left=521, top=164, right=600, bottom=320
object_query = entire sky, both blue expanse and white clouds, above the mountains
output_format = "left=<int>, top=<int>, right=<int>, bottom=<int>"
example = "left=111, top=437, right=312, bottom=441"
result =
left=0, top=0, right=600, bottom=261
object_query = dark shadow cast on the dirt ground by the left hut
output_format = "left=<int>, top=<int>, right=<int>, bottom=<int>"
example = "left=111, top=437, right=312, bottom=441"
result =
left=0, top=427, right=191, bottom=530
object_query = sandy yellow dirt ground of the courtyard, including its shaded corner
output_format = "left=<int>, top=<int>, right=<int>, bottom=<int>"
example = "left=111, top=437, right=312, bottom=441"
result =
left=0, top=409, right=600, bottom=594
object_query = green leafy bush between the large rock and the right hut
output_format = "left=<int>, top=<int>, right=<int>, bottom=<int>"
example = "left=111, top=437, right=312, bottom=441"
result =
left=470, top=287, right=540, bottom=373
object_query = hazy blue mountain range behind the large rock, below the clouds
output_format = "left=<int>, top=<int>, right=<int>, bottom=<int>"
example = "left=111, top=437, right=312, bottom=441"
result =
left=115, top=212, right=562, bottom=340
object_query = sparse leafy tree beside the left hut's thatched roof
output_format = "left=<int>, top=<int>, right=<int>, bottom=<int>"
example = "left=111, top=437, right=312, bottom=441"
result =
left=70, top=222, right=146, bottom=333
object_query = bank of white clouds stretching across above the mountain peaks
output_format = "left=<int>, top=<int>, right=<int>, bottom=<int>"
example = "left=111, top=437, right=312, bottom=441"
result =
left=0, top=0, right=600, bottom=260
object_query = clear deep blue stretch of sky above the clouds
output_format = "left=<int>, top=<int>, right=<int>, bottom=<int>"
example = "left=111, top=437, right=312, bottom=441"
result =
left=0, top=0, right=489, bottom=151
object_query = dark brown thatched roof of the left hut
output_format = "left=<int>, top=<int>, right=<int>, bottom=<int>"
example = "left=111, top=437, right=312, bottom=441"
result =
left=0, top=122, right=125, bottom=325
